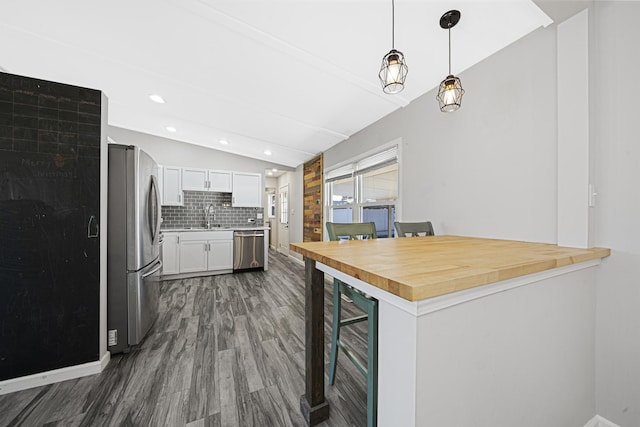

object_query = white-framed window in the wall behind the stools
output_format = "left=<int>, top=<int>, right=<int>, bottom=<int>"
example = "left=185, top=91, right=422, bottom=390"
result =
left=325, top=146, right=398, bottom=237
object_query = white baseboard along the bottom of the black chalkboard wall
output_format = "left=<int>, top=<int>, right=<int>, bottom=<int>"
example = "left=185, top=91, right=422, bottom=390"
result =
left=0, top=351, right=111, bottom=395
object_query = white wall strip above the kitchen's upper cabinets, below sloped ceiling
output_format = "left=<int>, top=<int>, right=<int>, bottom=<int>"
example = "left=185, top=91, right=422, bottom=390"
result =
left=108, top=126, right=291, bottom=175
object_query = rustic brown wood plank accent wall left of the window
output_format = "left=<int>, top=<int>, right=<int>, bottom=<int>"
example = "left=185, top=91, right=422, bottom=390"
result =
left=303, top=154, right=324, bottom=242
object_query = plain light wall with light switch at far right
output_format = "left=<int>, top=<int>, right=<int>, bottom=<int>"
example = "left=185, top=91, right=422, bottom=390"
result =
left=591, top=2, right=640, bottom=427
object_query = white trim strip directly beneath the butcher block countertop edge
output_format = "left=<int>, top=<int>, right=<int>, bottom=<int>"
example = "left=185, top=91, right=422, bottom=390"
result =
left=316, top=259, right=601, bottom=317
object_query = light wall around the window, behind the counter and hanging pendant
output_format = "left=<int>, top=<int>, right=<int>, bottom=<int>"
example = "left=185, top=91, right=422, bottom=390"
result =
left=324, top=27, right=557, bottom=243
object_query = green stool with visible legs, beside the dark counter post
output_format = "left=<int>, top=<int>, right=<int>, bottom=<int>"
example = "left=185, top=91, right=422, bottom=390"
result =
left=326, top=222, right=378, bottom=427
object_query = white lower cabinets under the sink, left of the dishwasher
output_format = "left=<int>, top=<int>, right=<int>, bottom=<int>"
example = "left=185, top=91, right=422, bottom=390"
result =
left=162, top=230, right=233, bottom=275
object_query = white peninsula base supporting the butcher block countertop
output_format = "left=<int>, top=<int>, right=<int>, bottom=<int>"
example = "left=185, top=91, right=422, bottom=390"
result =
left=317, top=259, right=601, bottom=427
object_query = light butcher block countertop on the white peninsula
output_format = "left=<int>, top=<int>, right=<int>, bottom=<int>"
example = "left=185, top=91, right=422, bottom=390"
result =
left=290, top=236, right=611, bottom=301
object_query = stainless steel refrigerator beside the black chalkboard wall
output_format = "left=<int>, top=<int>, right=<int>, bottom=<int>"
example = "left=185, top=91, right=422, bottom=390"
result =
left=107, top=144, right=162, bottom=354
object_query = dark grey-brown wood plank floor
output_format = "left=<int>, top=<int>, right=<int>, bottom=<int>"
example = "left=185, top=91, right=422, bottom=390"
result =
left=0, top=251, right=366, bottom=427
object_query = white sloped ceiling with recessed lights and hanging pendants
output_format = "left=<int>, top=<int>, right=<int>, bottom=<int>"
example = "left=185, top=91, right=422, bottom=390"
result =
left=0, top=0, right=551, bottom=167
